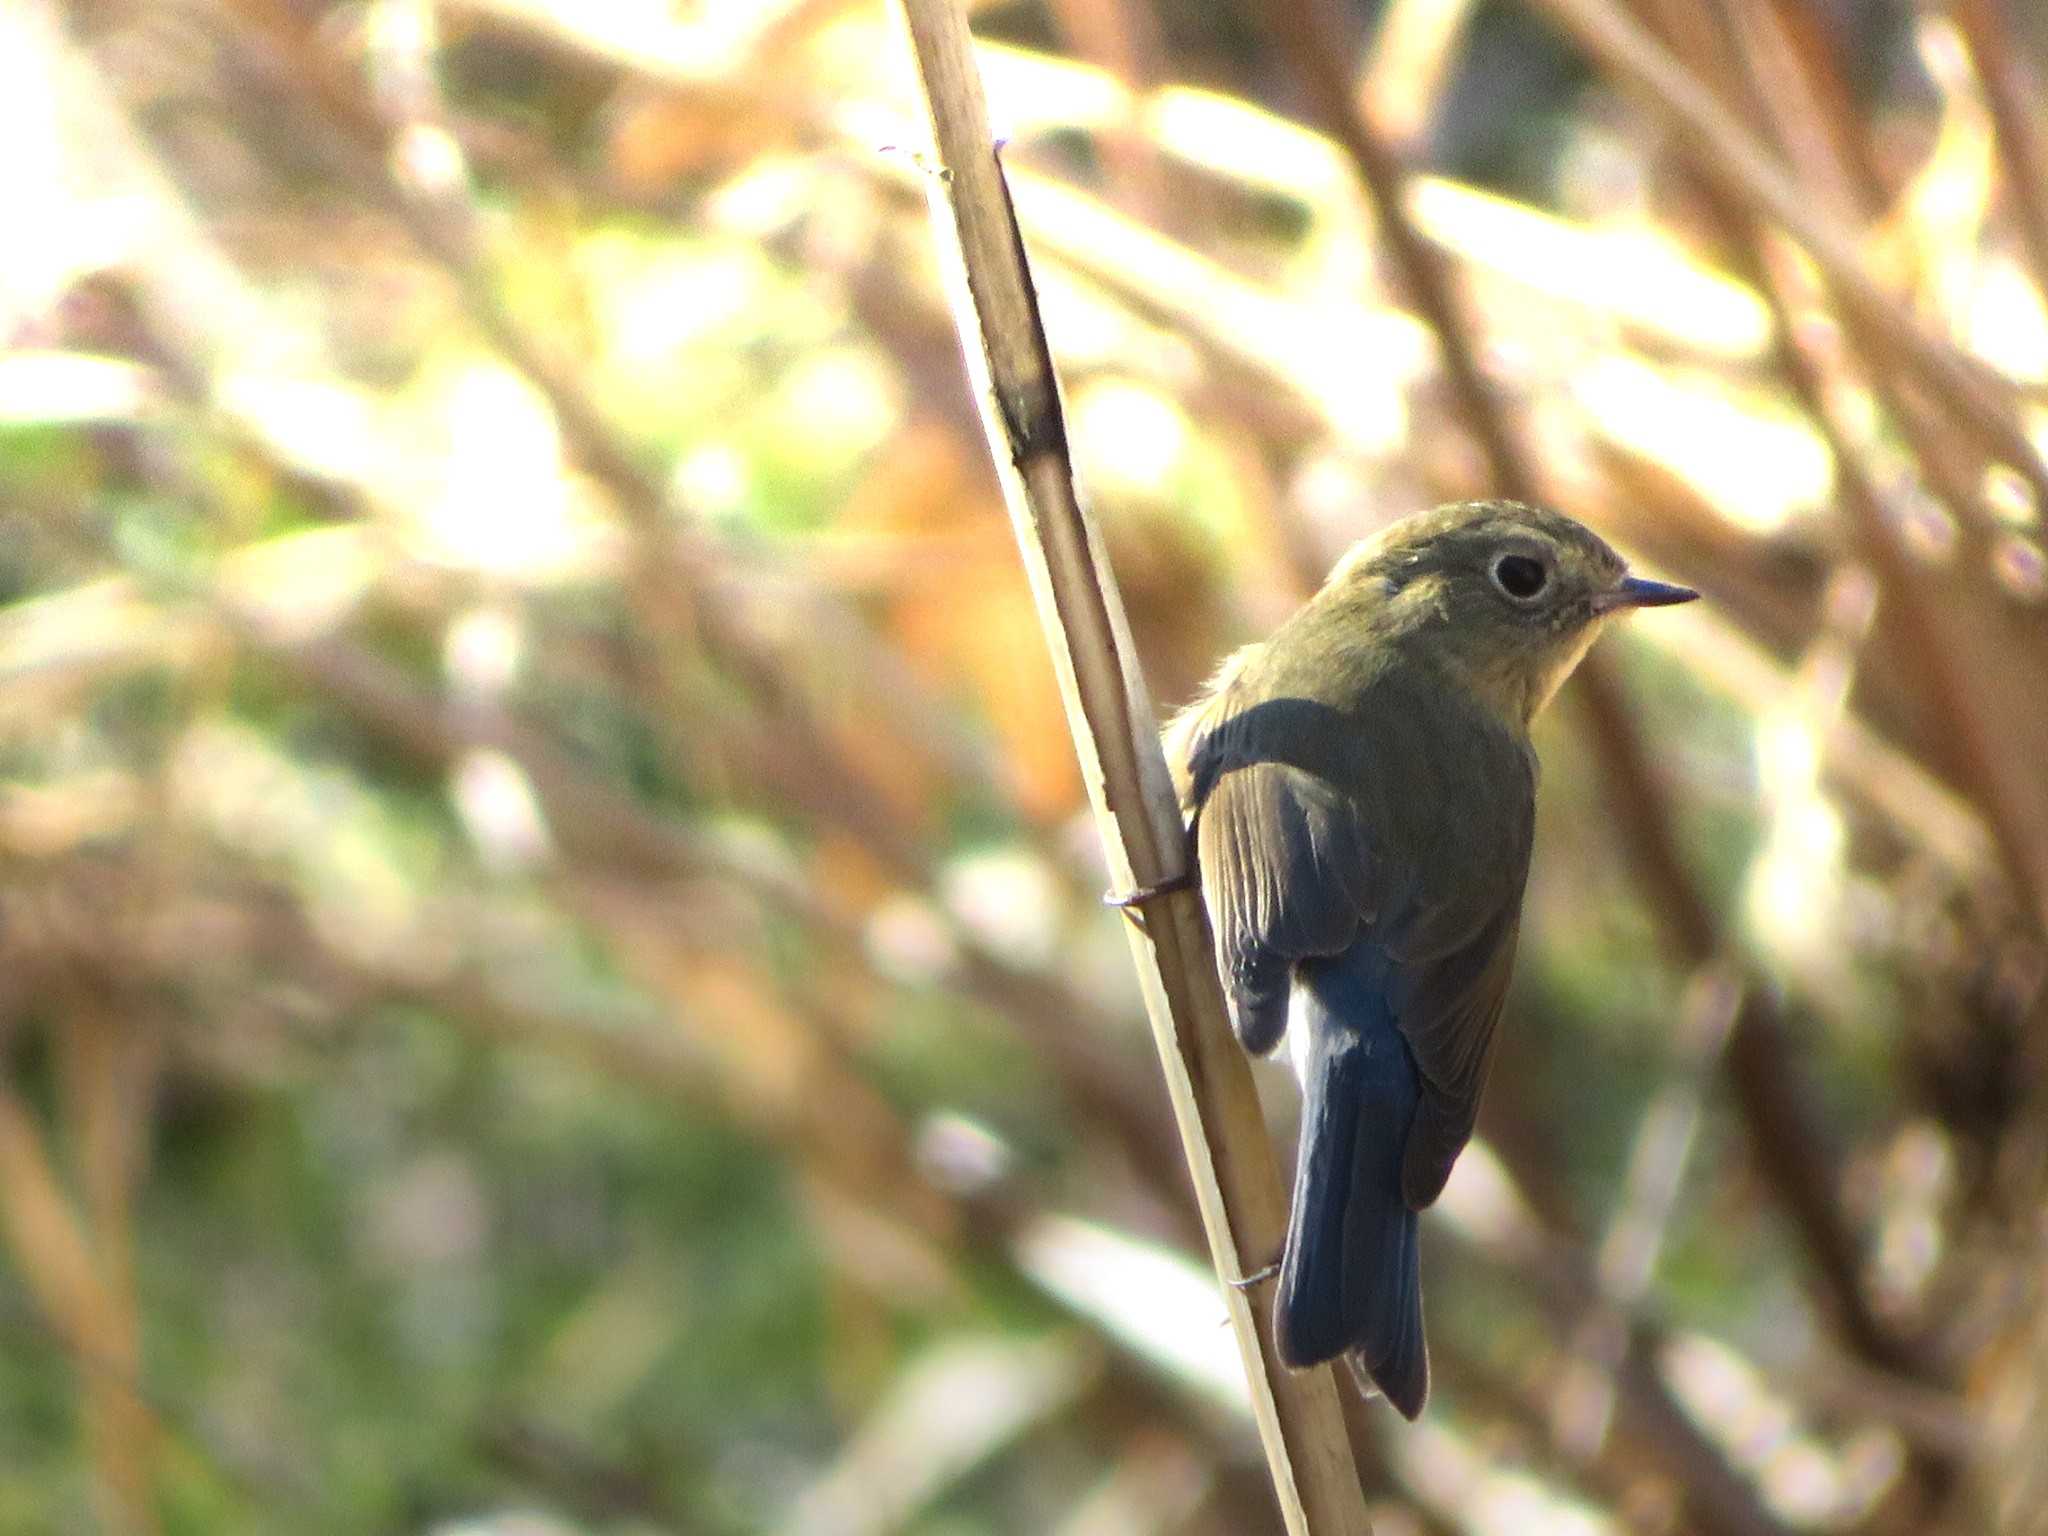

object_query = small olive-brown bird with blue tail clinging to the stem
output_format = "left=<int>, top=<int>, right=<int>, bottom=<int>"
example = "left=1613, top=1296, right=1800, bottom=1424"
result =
left=1165, top=502, right=1700, bottom=1419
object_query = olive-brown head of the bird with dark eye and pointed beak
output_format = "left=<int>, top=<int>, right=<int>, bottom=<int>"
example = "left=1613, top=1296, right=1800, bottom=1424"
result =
left=1327, top=502, right=1700, bottom=725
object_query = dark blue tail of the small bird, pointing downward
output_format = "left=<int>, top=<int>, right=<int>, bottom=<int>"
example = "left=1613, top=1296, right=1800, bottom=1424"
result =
left=1274, top=944, right=1430, bottom=1419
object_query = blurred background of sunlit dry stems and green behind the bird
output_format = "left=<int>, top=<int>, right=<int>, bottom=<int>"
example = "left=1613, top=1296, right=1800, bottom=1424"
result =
left=0, top=0, right=2048, bottom=1536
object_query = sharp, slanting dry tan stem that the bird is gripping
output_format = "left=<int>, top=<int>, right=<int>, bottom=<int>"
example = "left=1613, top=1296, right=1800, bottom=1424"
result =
left=903, top=0, right=1368, bottom=1536
